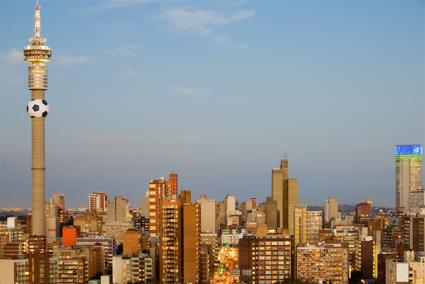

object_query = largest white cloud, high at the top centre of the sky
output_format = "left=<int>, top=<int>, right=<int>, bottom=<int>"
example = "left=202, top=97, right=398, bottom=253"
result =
left=159, top=9, right=255, bottom=35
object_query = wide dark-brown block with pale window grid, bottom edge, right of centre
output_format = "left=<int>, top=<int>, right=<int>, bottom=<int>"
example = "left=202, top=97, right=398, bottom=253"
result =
left=239, top=235, right=292, bottom=283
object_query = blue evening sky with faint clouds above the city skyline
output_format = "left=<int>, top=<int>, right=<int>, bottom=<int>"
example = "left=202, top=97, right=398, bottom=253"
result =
left=0, top=0, right=425, bottom=207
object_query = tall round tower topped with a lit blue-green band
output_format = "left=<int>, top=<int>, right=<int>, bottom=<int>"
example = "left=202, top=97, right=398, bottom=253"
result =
left=396, top=145, right=424, bottom=212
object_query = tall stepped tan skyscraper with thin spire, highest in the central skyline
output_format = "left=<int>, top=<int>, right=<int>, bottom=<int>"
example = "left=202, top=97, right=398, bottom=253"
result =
left=272, top=159, right=298, bottom=234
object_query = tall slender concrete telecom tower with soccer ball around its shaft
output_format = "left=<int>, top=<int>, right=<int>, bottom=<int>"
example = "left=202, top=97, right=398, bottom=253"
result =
left=24, top=3, right=52, bottom=236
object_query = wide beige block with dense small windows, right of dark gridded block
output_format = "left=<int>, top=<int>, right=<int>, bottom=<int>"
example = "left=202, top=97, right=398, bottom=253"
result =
left=296, top=243, right=348, bottom=284
